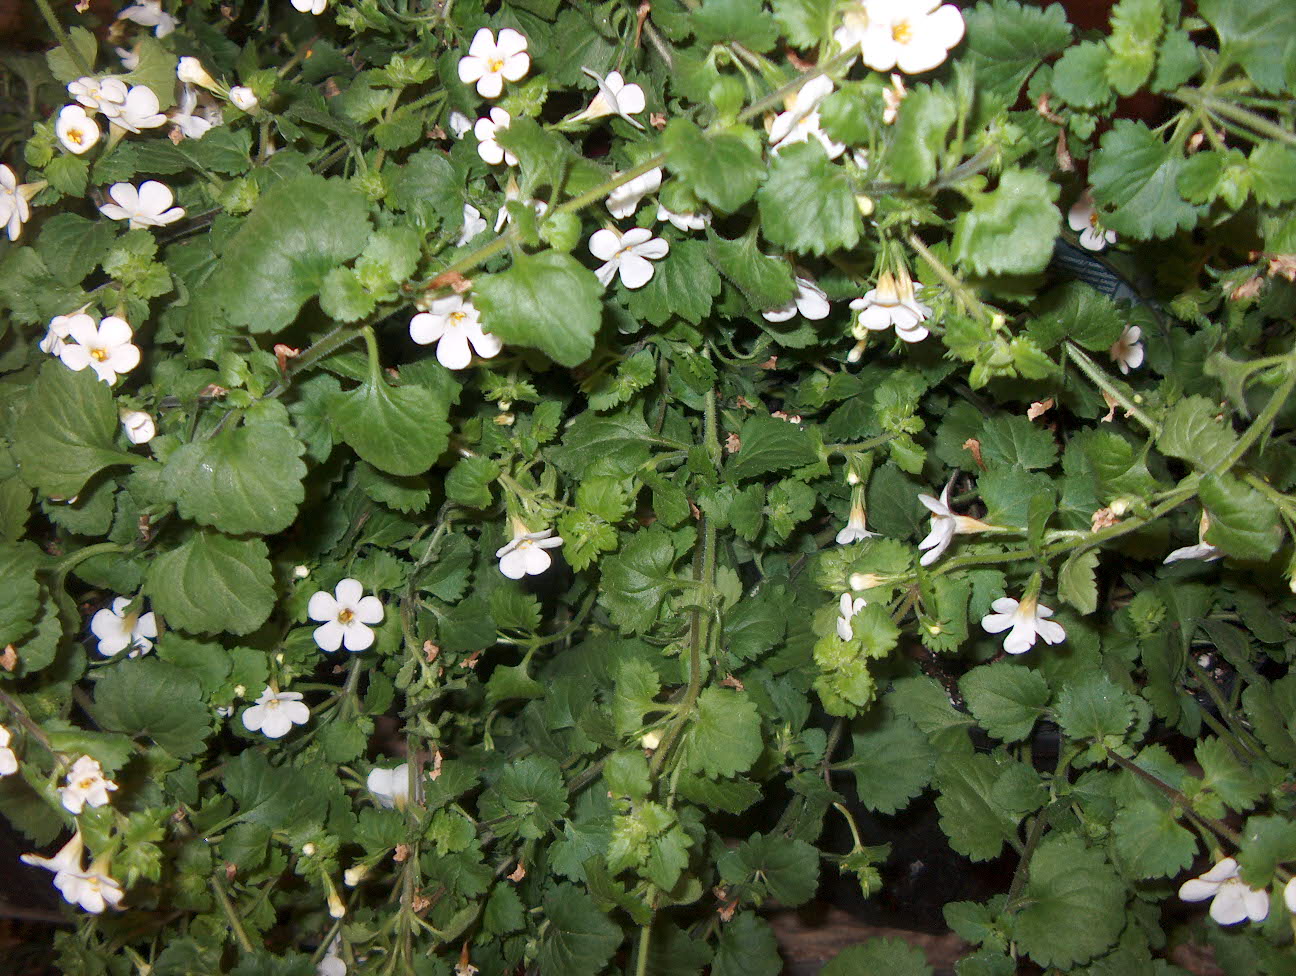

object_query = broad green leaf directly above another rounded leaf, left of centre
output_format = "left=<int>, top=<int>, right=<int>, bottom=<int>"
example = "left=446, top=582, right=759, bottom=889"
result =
left=162, top=424, right=306, bottom=535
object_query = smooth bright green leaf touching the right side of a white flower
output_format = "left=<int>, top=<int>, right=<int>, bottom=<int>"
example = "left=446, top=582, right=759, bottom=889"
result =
left=473, top=251, right=603, bottom=367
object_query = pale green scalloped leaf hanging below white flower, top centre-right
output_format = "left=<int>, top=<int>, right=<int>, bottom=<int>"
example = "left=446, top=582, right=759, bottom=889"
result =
left=756, top=139, right=861, bottom=255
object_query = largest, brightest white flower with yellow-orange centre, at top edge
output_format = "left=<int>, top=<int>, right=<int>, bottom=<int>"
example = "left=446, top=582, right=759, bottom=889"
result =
left=832, top=0, right=964, bottom=75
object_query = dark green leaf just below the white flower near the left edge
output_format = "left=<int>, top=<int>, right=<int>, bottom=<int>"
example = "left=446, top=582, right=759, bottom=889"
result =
left=93, top=657, right=211, bottom=760
